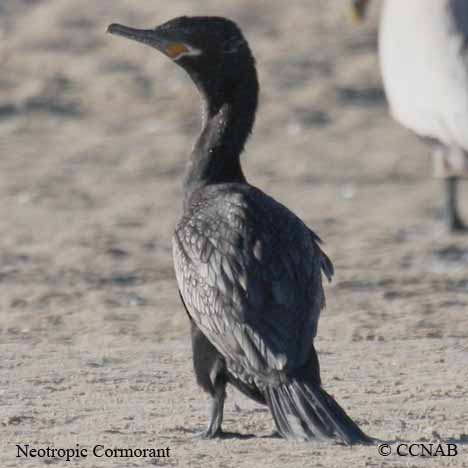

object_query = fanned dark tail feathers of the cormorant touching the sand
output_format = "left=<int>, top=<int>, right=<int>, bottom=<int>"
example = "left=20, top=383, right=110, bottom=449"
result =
left=266, top=379, right=375, bottom=445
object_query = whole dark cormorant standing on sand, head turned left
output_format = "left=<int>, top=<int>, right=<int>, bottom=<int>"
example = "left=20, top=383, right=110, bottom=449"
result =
left=109, top=17, right=373, bottom=444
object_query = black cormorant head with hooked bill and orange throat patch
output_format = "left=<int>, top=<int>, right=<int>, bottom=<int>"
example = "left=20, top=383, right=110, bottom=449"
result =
left=108, top=16, right=258, bottom=111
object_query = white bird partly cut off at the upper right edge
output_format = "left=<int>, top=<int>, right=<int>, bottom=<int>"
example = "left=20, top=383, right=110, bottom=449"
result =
left=352, top=0, right=468, bottom=231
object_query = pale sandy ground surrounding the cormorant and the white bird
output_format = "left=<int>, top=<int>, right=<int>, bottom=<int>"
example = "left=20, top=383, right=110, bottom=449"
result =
left=0, top=0, right=468, bottom=468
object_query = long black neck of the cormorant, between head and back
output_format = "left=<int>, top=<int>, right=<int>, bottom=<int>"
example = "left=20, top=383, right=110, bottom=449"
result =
left=184, top=62, right=258, bottom=201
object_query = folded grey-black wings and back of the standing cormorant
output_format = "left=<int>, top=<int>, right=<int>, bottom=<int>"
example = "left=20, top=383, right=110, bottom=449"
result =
left=173, top=184, right=333, bottom=377
